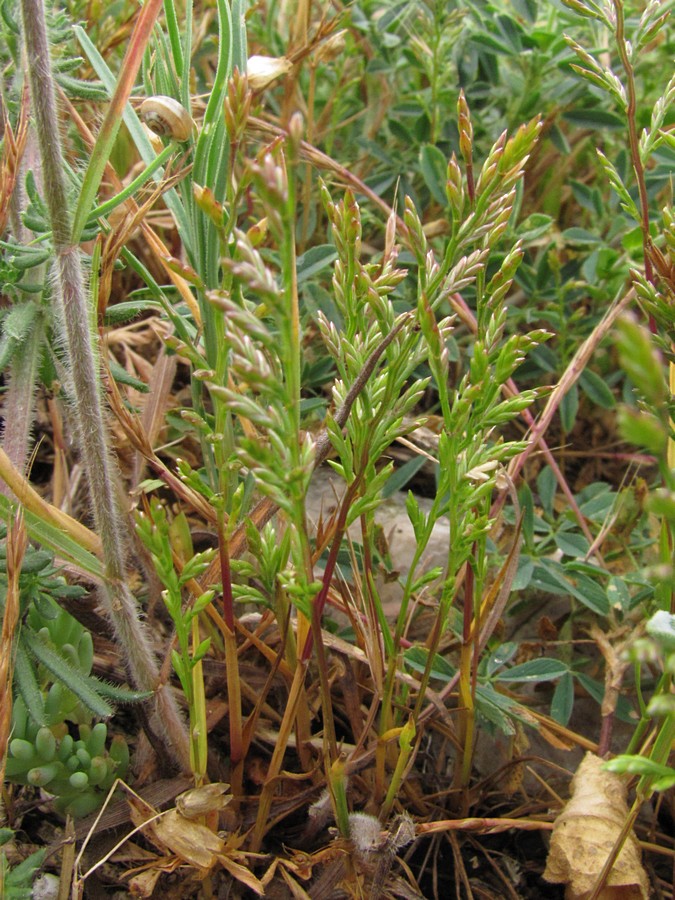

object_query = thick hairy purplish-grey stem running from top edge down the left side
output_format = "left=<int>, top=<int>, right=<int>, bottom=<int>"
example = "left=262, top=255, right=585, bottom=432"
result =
left=21, top=0, right=189, bottom=767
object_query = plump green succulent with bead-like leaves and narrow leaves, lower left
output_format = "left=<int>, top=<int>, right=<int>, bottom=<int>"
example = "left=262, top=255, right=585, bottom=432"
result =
left=0, top=531, right=146, bottom=816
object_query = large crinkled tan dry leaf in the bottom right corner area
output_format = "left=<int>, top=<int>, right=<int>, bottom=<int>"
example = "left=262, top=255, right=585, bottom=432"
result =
left=544, top=753, right=649, bottom=900
